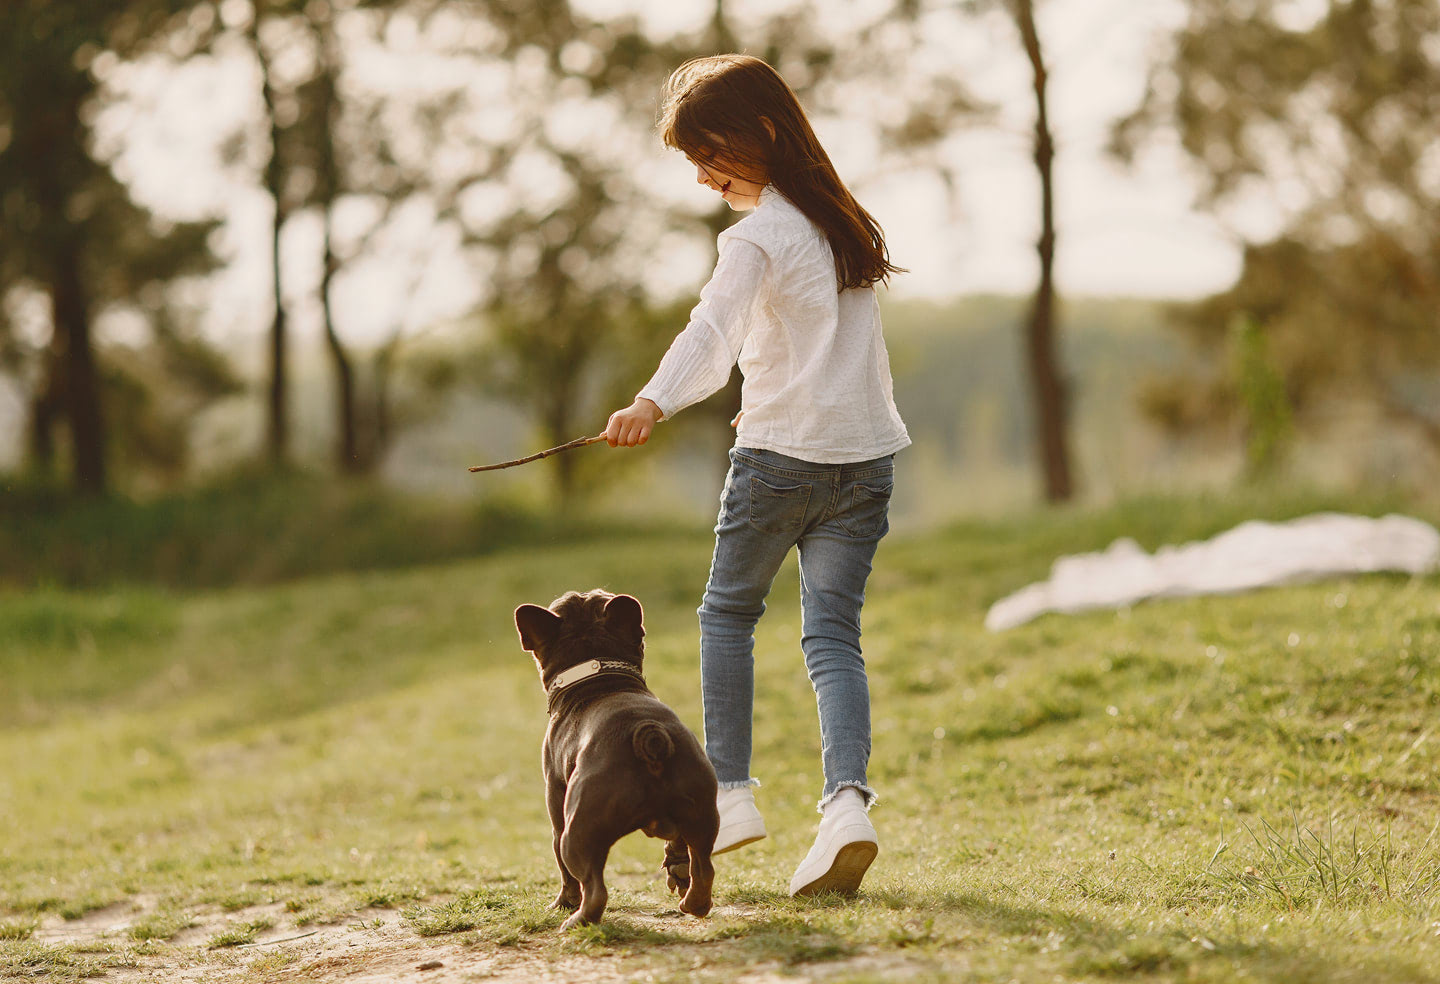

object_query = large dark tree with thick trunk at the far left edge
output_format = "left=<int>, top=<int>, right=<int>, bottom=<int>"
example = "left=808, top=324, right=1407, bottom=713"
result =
left=0, top=0, right=224, bottom=494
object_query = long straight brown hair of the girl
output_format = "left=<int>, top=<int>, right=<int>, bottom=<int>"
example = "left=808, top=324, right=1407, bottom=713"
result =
left=657, top=55, right=904, bottom=290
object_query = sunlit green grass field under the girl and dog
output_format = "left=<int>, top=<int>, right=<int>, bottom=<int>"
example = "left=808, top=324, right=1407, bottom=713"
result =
left=0, top=489, right=1440, bottom=984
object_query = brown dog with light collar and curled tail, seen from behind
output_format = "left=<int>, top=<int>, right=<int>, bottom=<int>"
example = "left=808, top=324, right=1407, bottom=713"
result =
left=516, top=591, right=720, bottom=929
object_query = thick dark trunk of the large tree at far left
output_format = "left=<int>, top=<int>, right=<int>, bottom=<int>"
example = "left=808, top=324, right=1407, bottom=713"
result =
left=50, top=236, right=105, bottom=496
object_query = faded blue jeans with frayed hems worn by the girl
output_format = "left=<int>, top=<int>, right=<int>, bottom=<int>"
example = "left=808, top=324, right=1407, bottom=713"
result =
left=700, top=448, right=894, bottom=807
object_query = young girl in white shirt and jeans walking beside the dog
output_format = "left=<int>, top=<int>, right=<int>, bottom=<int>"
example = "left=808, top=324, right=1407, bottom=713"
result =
left=605, top=55, right=910, bottom=895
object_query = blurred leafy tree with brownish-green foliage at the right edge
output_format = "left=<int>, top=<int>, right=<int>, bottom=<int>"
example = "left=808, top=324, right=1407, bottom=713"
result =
left=1113, top=0, right=1440, bottom=452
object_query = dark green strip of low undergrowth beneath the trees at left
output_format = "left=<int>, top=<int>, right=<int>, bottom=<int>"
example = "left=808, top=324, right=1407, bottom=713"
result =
left=0, top=473, right=688, bottom=587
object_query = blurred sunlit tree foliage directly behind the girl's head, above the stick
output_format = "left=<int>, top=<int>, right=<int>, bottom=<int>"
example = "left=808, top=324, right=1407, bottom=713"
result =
left=362, top=1, right=976, bottom=500
